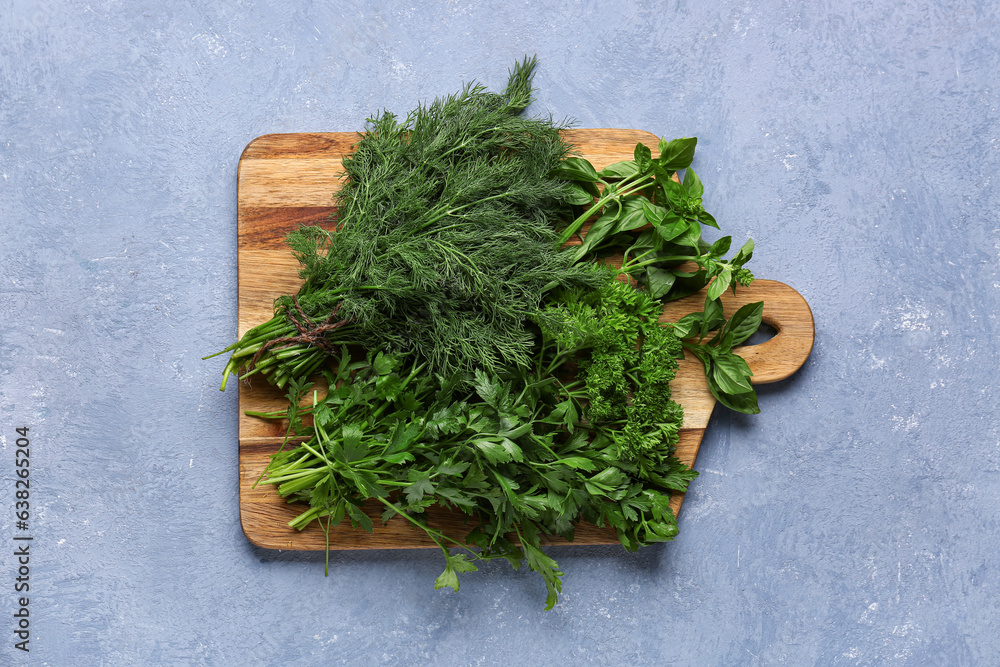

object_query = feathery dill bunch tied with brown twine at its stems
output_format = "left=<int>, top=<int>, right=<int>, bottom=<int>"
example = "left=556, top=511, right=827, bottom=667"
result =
left=214, top=58, right=595, bottom=386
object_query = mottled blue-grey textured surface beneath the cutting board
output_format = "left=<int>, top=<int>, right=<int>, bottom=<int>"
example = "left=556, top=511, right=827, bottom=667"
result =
left=0, top=0, right=1000, bottom=665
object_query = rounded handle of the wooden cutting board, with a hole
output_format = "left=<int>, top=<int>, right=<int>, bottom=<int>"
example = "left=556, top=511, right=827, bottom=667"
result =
left=722, top=280, right=815, bottom=384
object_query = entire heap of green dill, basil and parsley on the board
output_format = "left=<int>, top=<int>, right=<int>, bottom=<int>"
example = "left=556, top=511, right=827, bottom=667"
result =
left=220, top=59, right=762, bottom=608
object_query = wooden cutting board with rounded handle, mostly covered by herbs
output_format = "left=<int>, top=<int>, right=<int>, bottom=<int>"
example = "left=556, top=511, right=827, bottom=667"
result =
left=237, top=129, right=813, bottom=550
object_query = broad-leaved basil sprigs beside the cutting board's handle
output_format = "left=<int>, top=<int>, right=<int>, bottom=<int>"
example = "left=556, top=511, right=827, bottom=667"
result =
left=558, top=137, right=763, bottom=414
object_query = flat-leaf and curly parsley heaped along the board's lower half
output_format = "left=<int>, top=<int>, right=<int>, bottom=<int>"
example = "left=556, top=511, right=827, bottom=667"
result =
left=252, top=267, right=697, bottom=608
